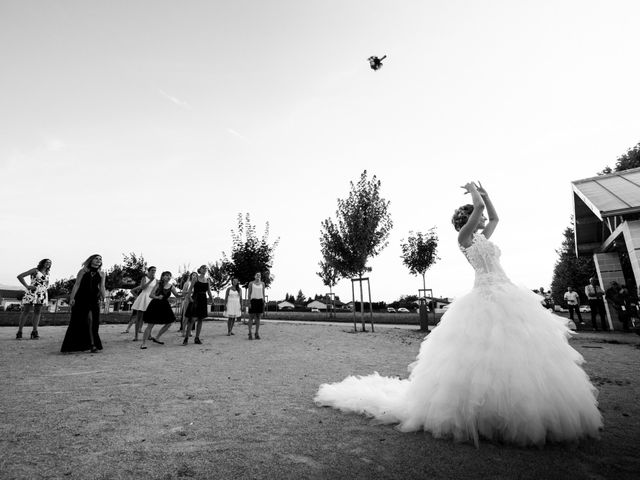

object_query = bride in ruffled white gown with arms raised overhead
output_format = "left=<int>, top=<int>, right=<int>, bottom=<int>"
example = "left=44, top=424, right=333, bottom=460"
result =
left=315, top=183, right=602, bottom=446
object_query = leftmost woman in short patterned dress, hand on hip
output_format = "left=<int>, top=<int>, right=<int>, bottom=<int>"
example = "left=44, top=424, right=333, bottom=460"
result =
left=16, top=258, right=51, bottom=340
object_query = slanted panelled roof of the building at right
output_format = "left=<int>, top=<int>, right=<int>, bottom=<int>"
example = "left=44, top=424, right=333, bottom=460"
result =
left=571, top=168, right=640, bottom=255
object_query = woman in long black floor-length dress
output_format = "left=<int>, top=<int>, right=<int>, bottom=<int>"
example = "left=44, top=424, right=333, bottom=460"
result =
left=60, top=254, right=105, bottom=353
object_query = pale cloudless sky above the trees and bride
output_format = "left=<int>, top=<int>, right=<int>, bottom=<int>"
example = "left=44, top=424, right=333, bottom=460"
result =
left=0, top=0, right=640, bottom=302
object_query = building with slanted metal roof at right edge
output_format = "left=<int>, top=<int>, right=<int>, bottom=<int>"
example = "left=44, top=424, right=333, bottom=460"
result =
left=571, top=168, right=640, bottom=328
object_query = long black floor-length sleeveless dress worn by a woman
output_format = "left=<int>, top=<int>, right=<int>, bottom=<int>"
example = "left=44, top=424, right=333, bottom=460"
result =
left=60, top=272, right=102, bottom=352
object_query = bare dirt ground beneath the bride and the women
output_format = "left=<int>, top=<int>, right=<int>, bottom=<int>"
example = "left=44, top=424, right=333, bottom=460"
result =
left=0, top=321, right=640, bottom=479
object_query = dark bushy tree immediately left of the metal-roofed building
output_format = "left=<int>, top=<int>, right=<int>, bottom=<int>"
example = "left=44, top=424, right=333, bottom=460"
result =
left=551, top=226, right=596, bottom=305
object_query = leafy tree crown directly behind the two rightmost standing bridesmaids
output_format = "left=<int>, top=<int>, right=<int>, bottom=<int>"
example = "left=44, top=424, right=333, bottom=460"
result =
left=222, top=213, right=280, bottom=287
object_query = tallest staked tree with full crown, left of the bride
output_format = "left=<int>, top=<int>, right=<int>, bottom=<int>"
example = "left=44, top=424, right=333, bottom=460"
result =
left=320, top=170, right=393, bottom=331
